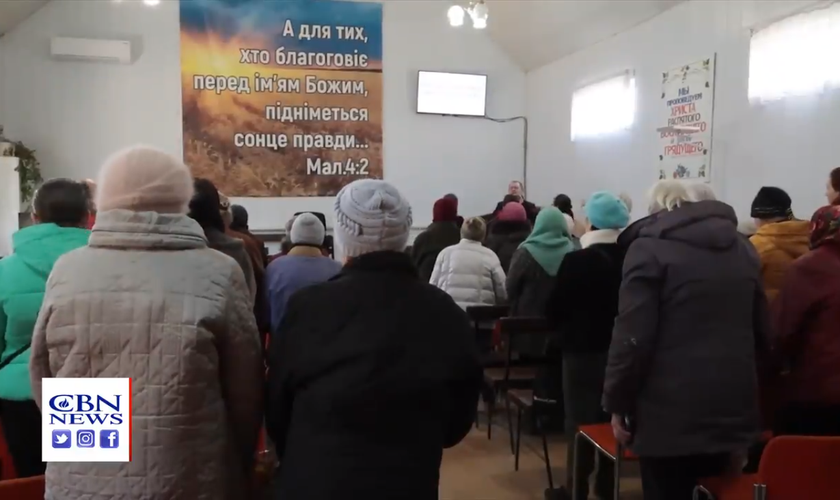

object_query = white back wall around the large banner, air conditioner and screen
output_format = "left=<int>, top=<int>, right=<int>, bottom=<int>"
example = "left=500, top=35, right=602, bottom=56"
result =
left=0, top=0, right=525, bottom=229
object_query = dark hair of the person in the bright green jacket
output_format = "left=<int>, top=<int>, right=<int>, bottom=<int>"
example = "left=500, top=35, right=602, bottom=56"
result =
left=32, top=179, right=91, bottom=227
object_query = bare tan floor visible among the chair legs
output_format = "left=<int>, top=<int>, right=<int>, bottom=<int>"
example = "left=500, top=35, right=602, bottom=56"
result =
left=440, top=423, right=643, bottom=500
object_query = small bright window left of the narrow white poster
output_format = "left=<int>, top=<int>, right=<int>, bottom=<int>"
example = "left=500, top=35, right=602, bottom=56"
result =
left=572, top=75, right=636, bottom=141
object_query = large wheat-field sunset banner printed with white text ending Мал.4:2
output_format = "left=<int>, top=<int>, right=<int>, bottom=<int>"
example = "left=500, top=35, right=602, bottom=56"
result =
left=180, top=0, right=382, bottom=197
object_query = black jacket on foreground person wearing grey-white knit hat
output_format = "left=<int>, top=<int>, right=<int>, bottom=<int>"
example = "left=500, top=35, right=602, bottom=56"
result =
left=266, top=252, right=482, bottom=500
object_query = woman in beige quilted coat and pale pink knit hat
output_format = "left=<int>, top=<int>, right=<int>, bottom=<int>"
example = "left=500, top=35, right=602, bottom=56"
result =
left=30, top=147, right=263, bottom=500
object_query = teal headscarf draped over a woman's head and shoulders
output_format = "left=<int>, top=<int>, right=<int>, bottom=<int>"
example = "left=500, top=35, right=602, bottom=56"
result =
left=519, top=207, right=575, bottom=276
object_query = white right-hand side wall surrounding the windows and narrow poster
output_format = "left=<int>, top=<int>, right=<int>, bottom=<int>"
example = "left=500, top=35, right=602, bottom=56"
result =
left=526, top=1, right=840, bottom=223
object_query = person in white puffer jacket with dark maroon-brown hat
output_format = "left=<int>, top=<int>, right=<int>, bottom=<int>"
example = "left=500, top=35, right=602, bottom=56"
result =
left=429, top=217, right=507, bottom=309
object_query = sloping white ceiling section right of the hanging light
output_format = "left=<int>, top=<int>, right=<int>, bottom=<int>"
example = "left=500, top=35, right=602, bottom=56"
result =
left=486, top=0, right=681, bottom=71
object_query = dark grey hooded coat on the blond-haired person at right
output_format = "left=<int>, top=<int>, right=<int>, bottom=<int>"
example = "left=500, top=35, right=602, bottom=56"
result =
left=604, top=201, right=769, bottom=457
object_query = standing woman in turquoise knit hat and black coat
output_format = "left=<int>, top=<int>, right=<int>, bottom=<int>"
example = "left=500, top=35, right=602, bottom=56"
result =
left=545, top=191, right=630, bottom=500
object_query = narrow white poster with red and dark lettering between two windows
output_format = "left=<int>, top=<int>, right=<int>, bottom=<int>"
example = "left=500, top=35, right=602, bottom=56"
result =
left=657, top=56, right=715, bottom=182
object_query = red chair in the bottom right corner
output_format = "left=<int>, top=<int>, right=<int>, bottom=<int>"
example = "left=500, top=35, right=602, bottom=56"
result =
left=694, top=436, right=840, bottom=500
